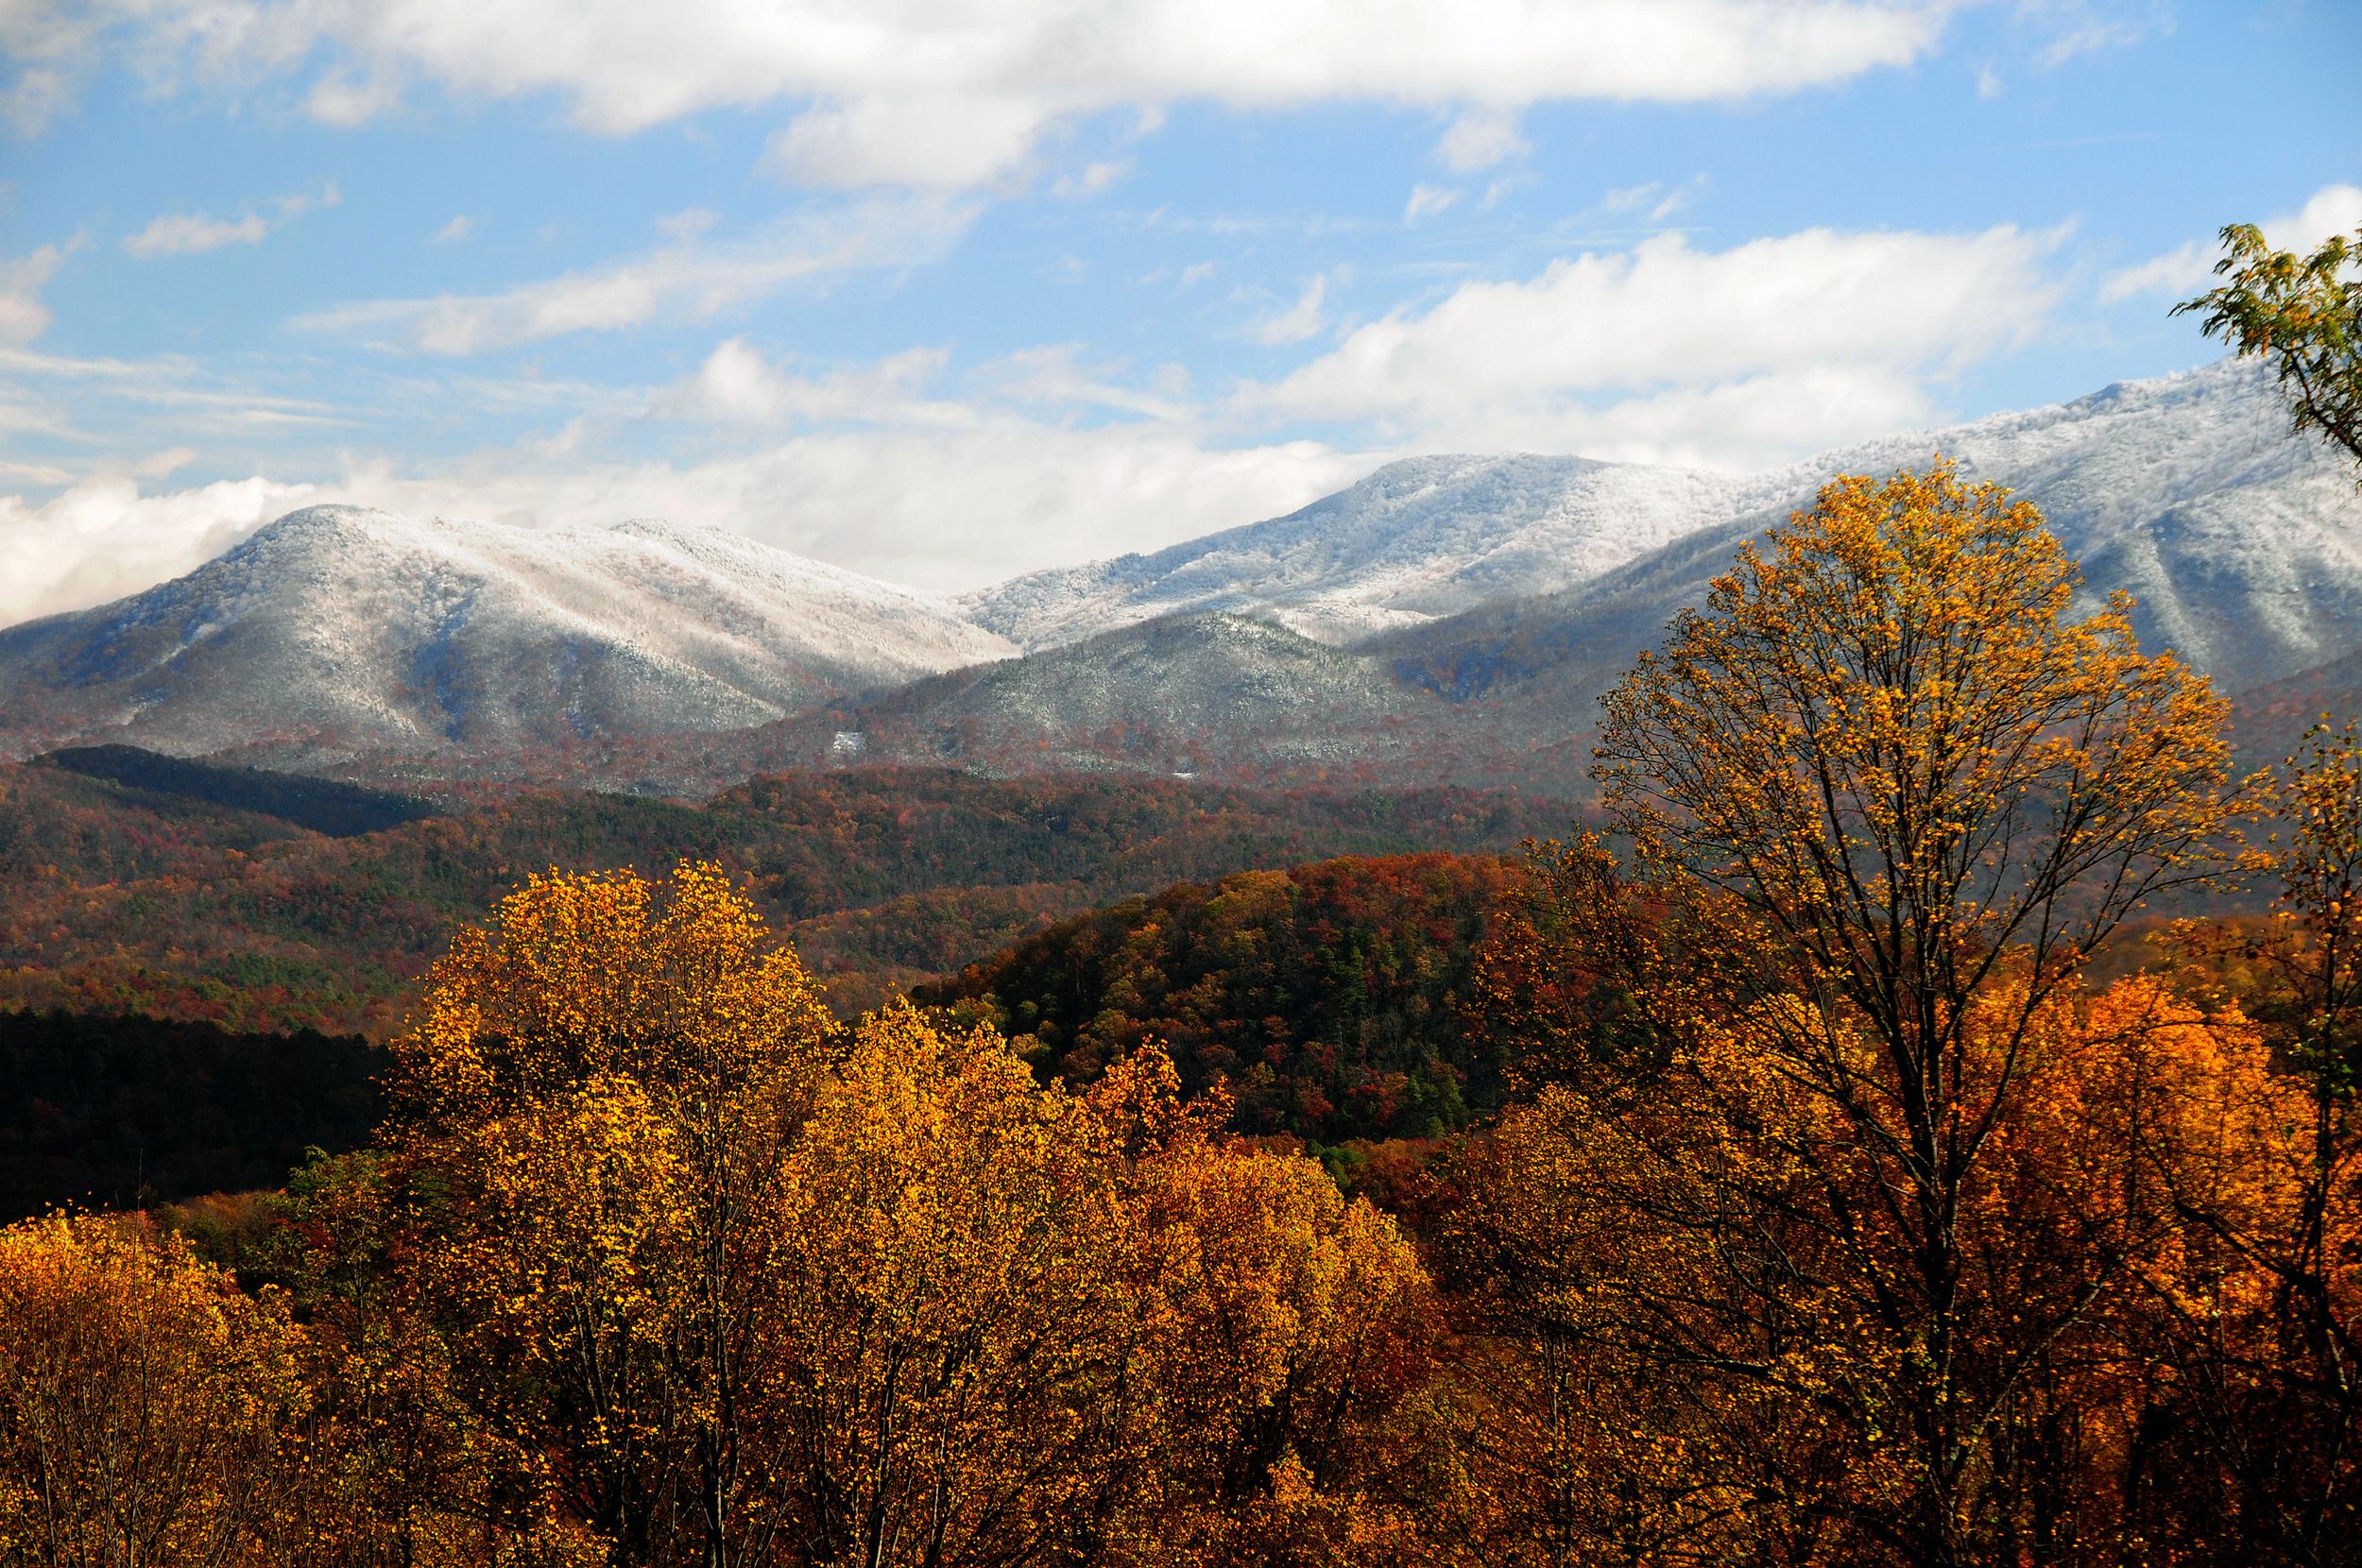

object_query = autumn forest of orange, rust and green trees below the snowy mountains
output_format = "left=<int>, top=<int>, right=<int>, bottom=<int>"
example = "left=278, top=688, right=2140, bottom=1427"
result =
left=0, top=236, right=2362, bottom=1568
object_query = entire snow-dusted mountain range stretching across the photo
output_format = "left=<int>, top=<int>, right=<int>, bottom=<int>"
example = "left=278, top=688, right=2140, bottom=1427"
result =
left=0, top=364, right=2362, bottom=789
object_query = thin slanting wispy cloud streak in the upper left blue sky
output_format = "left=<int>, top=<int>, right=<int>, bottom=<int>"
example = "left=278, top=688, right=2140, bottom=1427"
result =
left=296, top=198, right=976, bottom=354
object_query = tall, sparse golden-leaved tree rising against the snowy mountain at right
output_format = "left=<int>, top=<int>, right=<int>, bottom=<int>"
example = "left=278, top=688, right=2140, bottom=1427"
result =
left=1463, top=466, right=2237, bottom=1563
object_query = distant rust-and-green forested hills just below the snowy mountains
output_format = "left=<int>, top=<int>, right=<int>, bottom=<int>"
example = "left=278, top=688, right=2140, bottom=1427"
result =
left=0, top=765, right=1568, bottom=1037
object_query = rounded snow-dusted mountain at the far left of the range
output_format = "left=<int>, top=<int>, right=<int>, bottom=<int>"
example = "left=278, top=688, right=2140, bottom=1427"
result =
left=0, top=505, right=1011, bottom=754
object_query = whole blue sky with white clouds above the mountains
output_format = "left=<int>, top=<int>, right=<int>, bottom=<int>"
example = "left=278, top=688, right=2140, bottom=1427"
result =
left=0, top=0, right=2362, bottom=622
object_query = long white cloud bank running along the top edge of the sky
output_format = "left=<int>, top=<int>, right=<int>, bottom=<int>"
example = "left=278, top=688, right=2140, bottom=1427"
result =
left=45, top=0, right=1951, bottom=189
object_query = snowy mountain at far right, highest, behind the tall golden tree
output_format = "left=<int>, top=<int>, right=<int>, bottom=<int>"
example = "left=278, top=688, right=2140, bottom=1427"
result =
left=1365, top=364, right=2362, bottom=723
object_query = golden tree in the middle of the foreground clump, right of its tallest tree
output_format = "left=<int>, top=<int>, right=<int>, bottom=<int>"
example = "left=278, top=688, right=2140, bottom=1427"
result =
left=765, top=1006, right=1157, bottom=1563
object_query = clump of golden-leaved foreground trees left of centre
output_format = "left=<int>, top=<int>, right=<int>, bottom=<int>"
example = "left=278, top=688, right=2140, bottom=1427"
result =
left=370, top=867, right=1431, bottom=1568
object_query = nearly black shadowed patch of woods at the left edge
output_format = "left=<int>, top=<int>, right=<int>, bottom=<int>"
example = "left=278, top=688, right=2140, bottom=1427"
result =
left=0, top=1014, right=385, bottom=1223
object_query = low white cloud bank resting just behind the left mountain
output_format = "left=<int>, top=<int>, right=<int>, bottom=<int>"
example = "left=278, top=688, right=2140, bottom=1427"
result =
left=0, top=318, right=1387, bottom=623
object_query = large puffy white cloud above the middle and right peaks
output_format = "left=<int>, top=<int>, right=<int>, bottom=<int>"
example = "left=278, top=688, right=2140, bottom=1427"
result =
left=1231, top=227, right=2060, bottom=461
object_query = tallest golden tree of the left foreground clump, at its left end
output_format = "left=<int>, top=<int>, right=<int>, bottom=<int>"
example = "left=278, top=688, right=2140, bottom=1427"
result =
left=390, top=864, right=834, bottom=1563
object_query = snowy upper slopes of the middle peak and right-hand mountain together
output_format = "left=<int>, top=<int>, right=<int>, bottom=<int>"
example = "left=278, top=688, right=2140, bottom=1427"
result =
left=962, top=362, right=2362, bottom=669
